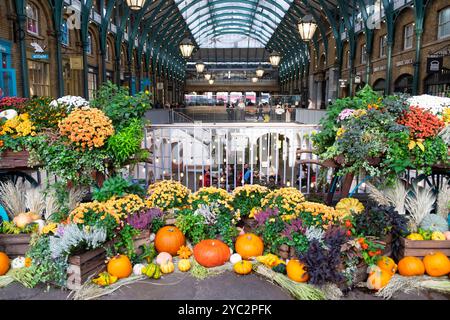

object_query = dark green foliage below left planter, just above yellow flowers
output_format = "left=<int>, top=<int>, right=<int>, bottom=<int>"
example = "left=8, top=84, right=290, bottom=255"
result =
left=92, top=176, right=145, bottom=201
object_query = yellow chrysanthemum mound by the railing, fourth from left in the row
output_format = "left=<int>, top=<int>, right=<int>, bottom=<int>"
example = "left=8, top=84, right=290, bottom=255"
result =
left=261, top=187, right=305, bottom=219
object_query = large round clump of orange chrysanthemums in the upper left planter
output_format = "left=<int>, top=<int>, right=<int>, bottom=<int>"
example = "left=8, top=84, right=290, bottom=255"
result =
left=58, top=107, right=114, bottom=150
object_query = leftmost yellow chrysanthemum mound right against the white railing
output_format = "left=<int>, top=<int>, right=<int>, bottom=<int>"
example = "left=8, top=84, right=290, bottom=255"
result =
left=146, top=180, right=191, bottom=211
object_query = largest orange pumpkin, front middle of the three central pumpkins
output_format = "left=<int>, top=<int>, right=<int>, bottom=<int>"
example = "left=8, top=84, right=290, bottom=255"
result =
left=194, top=239, right=230, bottom=268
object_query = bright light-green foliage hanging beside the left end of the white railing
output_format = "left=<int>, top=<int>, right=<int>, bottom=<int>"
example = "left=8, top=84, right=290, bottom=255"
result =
left=107, top=119, right=144, bottom=166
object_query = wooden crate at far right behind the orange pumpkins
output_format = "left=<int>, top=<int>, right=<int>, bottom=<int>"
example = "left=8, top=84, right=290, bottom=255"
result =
left=400, top=238, right=450, bottom=258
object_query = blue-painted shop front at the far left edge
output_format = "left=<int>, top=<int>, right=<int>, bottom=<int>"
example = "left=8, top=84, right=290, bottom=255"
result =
left=0, top=39, right=17, bottom=98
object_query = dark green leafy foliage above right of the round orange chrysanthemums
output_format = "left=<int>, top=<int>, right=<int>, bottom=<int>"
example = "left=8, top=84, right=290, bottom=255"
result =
left=91, top=81, right=152, bottom=131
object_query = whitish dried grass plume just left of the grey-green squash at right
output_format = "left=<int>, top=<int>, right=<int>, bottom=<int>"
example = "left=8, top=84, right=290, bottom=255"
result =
left=406, top=183, right=436, bottom=227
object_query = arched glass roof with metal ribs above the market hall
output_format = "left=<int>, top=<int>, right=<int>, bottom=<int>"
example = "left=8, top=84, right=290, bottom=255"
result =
left=175, top=0, right=294, bottom=48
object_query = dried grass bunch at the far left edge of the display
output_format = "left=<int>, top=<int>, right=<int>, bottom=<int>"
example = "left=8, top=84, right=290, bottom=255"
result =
left=0, top=181, right=26, bottom=219
